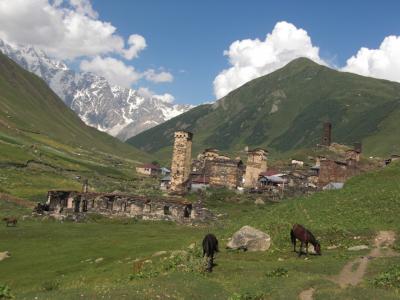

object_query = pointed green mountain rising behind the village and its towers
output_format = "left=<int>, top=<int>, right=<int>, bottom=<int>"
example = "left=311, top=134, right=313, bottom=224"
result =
left=128, top=58, right=400, bottom=155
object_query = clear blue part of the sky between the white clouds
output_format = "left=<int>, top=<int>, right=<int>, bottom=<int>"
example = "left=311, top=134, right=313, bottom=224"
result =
left=92, top=0, right=400, bottom=103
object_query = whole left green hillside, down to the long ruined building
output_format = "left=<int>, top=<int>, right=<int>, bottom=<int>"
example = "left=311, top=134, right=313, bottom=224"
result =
left=0, top=53, right=155, bottom=201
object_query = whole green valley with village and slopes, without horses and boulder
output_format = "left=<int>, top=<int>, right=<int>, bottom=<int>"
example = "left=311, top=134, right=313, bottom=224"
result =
left=0, top=29, right=400, bottom=300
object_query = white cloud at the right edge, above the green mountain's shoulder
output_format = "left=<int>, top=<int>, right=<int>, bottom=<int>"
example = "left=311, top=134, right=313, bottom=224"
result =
left=342, top=35, right=400, bottom=82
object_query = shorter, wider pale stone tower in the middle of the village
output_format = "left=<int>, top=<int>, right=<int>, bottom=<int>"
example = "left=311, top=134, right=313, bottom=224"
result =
left=244, top=149, right=268, bottom=188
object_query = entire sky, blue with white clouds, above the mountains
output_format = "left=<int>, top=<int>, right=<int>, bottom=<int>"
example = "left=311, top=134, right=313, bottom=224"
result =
left=0, top=0, right=400, bottom=104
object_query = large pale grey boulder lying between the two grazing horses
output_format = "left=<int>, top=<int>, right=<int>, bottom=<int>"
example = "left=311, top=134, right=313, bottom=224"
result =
left=226, top=226, right=271, bottom=251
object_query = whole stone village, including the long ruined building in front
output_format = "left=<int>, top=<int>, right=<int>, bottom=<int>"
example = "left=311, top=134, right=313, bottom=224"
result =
left=39, top=123, right=392, bottom=224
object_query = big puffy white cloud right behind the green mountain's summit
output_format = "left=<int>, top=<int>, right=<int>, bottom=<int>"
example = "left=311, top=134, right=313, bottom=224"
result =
left=214, top=21, right=325, bottom=98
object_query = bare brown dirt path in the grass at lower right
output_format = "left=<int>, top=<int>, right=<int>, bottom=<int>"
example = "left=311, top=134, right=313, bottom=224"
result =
left=330, top=231, right=399, bottom=288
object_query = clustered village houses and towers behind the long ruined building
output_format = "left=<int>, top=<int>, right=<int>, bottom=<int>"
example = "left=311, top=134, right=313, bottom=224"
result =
left=136, top=123, right=376, bottom=197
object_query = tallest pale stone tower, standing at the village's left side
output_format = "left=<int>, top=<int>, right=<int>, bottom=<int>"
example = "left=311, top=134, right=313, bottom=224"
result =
left=170, top=131, right=193, bottom=194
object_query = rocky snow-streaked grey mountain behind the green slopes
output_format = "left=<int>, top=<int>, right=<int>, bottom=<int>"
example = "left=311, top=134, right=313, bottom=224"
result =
left=0, top=39, right=193, bottom=140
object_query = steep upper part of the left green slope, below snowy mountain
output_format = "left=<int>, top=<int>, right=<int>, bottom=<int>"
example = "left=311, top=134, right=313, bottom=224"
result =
left=0, top=53, right=148, bottom=158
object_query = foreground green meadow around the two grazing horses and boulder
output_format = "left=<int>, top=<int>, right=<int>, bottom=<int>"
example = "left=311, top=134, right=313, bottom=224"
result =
left=0, top=165, right=400, bottom=299
